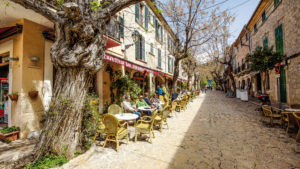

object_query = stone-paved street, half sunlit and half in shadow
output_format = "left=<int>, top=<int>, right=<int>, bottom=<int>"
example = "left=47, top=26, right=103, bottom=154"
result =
left=61, top=91, right=300, bottom=169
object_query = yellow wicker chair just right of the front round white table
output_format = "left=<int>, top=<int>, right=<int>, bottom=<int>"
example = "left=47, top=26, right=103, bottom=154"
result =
left=134, top=110, right=157, bottom=144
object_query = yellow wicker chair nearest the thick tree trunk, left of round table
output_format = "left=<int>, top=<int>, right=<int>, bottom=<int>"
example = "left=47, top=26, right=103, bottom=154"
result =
left=103, top=114, right=129, bottom=152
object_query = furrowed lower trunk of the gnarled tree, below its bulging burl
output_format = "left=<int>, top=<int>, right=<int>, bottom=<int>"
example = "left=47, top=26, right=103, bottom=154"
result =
left=35, top=67, right=92, bottom=158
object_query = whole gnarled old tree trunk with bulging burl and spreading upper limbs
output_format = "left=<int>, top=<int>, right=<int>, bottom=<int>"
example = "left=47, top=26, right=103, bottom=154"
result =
left=12, top=0, right=141, bottom=159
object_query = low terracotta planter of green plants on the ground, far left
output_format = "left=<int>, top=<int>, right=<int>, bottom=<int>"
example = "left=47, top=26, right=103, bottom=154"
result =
left=0, top=126, right=20, bottom=141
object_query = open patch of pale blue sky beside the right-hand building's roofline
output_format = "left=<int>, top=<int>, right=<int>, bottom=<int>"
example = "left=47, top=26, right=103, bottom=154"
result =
left=220, top=0, right=260, bottom=43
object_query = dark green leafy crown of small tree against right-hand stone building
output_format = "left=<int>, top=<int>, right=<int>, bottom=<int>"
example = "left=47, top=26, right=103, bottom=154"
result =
left=246, top=46, right=284, bottom=72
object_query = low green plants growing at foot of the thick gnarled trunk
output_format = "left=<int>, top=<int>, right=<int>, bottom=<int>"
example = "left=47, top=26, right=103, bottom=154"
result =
left=26, top=155, right=68, bottom=169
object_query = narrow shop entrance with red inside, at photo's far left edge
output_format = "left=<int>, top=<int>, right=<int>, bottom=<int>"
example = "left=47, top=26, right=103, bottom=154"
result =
left=0, top=52, right=10, bottom=126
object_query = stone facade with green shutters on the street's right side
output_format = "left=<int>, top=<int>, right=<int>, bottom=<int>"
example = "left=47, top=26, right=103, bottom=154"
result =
left=232, top=0, right=300, bottom=106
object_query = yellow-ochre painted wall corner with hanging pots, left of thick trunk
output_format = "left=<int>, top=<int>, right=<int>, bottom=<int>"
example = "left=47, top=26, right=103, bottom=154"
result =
left=2, top=19, right=48, bottom=138
